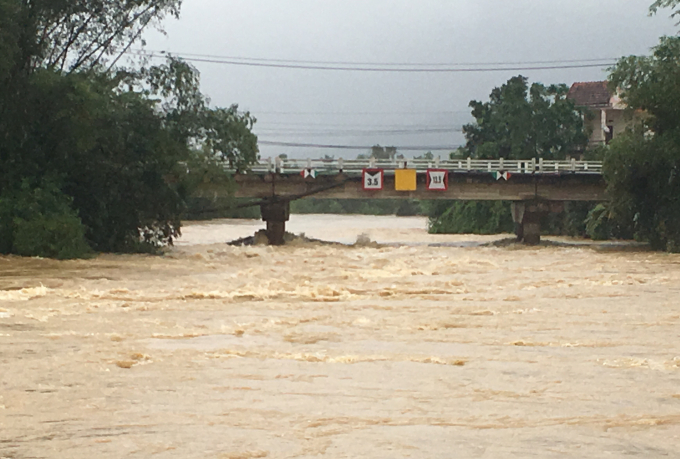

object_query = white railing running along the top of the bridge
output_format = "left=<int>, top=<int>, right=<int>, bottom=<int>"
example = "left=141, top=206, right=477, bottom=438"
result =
left=232, top=157, right=602, bottom=175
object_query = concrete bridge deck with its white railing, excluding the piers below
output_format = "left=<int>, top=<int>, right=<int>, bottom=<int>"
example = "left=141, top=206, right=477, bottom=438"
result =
left=212, top=158, right=606, bottom=201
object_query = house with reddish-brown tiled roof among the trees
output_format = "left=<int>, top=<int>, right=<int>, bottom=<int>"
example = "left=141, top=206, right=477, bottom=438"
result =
left=567, top=81, right=634, bottom=148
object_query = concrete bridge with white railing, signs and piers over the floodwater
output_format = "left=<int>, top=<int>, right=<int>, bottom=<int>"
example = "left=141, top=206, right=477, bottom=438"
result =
left=199, top=158, right=606, bottom=245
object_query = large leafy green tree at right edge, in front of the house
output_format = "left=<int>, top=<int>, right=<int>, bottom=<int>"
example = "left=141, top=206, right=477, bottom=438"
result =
left=604, top=37, right=680, bottom=252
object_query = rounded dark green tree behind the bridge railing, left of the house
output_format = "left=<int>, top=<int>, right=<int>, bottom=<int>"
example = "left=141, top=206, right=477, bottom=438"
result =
left=463, top=75, right=588, bottom=159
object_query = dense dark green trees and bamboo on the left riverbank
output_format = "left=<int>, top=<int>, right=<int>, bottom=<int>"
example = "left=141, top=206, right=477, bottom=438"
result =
left=0, top=0, right=257, bottom=258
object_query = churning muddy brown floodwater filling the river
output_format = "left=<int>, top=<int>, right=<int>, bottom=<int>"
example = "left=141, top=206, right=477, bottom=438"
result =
left=0, top=215, right=680, bottom=459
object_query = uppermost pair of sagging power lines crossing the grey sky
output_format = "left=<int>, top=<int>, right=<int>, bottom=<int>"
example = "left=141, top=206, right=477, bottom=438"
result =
left=134, top=53, right=614, bottom=73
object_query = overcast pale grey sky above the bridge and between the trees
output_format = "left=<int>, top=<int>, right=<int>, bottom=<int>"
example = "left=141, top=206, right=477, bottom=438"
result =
left=145, top=0, right=680, bottom=158
